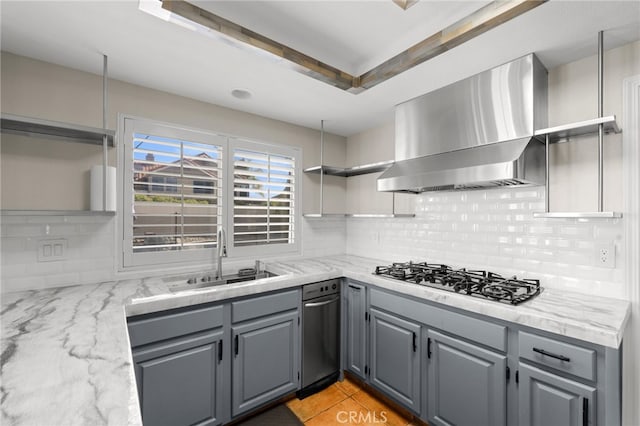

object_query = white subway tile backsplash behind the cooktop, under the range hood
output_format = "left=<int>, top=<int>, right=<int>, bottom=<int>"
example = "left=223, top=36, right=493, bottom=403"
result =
left=347, top=187, right=624, bottom=298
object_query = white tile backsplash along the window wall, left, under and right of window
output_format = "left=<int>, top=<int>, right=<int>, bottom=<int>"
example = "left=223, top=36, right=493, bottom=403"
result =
left=0, top=214, right=347, bottom=292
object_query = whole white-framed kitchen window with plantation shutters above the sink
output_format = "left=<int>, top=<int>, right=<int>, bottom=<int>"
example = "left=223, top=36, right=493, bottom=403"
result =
left=120, top=117, right=300, bottom=268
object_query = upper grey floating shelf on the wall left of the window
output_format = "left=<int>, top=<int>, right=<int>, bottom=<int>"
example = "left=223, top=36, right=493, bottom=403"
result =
left=0, top=114, right=115, bottom=146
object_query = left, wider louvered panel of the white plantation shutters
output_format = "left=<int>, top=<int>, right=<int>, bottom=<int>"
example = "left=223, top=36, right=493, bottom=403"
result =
left=132, top=133, right=223, bottom=253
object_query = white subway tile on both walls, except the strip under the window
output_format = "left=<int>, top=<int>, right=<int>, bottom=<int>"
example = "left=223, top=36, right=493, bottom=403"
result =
left=0, top=187, right=625, bottom=298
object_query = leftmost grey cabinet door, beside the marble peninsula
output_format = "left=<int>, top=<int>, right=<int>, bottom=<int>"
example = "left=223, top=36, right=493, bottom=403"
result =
left=133, top=331, right=223, bottom=426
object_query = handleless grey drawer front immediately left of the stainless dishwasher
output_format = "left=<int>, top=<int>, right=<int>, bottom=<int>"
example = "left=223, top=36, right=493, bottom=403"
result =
left=231, top=290, right=301, bottom=323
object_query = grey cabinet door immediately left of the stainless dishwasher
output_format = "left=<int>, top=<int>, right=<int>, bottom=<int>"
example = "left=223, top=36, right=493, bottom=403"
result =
left=232, top=310, right=300, bottom=416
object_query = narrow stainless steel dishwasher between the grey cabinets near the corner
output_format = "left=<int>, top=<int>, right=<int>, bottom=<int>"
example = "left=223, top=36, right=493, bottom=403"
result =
left=298, top=279, right=340, bottom=398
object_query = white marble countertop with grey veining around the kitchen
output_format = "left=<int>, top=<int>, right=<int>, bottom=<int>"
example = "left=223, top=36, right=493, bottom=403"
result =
left=0, top=256, right=630, bottom=425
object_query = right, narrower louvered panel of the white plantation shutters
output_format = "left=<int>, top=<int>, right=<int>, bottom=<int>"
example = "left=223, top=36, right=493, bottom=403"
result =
left=232, top=143, right=297, bottom=250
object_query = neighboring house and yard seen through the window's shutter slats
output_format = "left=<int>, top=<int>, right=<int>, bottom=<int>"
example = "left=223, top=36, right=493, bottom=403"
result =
left=133, top=148, right=294, bottom=251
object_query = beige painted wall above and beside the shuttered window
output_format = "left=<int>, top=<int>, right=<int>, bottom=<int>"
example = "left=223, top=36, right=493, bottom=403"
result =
left=0, top=52, right=346, bottom=212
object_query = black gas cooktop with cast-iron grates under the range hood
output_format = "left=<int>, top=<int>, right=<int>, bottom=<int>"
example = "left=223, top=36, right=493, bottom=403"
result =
left=374, top=262, right=542, bottom=305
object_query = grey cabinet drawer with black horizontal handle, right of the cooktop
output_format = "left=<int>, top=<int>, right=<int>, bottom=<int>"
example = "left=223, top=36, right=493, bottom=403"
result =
left=518, top=331, right=596, bottom=380
